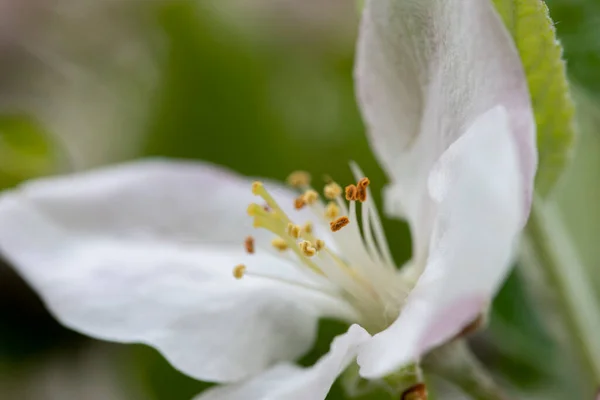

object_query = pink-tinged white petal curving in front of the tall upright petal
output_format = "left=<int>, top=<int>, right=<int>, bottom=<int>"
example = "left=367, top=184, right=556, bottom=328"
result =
left=358, top=107, right=524, bottom=377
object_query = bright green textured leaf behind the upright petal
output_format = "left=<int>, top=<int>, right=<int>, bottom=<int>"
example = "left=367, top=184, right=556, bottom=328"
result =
left=494, top=0, right=575, bottom=197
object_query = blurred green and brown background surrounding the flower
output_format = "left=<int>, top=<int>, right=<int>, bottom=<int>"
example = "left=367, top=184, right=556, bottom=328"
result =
left=0, top=0, right=600, bottom=400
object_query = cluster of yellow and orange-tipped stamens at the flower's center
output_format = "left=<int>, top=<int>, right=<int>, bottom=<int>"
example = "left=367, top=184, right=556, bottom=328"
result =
left=234, top=165, right=413, bottom=333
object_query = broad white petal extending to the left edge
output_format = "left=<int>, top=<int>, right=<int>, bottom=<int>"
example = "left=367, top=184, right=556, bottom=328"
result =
left=0, top=162, right=350, bottom=381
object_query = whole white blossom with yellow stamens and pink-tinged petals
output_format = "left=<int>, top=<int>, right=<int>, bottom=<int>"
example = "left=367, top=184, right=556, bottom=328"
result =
left=0, top=0, right=536, bottom=400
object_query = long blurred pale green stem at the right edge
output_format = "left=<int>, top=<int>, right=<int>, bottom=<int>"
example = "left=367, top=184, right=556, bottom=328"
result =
left=526, top=199, right=600, bottom=386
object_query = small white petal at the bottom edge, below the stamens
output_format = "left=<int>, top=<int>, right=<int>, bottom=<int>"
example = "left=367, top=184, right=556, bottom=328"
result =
left=195, top=325, right=370, bottom=400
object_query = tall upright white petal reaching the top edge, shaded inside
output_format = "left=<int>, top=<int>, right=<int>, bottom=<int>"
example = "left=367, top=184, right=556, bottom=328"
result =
left=355, top=0, right=537, bottom=261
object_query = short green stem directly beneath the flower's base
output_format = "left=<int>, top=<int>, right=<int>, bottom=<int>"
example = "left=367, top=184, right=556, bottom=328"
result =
left=424, top=339, right=509, bottom=400
